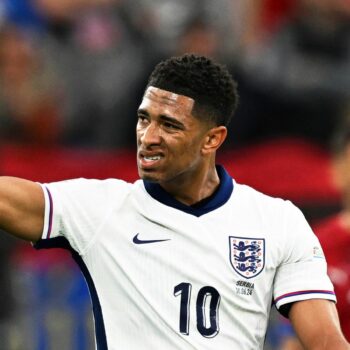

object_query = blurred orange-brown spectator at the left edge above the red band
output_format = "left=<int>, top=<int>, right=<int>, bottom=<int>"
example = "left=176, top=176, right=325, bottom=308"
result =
left=0, top=26, right=60, bottom=145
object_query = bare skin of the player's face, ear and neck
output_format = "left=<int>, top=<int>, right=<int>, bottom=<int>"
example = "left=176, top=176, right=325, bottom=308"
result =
left=136, top=87, right=227, bottom=205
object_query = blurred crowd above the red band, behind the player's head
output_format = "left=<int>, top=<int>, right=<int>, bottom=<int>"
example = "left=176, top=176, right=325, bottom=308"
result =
left=0, top=0, right=350, bottom=149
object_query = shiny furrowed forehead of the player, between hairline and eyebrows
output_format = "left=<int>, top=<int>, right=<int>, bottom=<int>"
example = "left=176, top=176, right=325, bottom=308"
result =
left=140, top=86, right=194, bottom=114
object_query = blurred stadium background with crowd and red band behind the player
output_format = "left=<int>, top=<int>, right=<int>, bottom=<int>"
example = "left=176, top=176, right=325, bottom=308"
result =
left=0, top=0, right=350, bottom=350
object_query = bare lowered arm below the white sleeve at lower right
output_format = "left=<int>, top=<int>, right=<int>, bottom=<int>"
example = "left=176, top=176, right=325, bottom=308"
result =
left=289, top=299, right=350, bottom=350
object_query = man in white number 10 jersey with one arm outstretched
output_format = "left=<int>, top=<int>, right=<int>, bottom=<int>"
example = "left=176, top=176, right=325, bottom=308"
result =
left=0, top=55, right=348, bottom=350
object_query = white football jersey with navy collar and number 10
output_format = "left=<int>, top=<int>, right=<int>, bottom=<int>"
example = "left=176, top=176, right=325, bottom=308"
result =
left=36, top=167, right=335, bottom=350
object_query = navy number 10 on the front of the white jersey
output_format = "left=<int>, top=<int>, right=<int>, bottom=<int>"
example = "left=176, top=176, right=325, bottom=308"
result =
left=174, top=282, right=221, bottom=338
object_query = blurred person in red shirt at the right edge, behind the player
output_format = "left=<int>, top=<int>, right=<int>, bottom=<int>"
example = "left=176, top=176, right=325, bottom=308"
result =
left=279, top=121, right=350, bottom=350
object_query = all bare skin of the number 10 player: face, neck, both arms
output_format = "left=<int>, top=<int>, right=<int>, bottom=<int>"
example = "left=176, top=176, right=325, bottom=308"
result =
left=0, top=87, right=349, bottom=350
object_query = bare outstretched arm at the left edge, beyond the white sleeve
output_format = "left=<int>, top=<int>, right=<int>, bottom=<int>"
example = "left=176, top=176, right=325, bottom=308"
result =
left=0, top=176, right=45, bottom=242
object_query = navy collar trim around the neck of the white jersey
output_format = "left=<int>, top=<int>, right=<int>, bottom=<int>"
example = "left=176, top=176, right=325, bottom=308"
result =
left=143, top=165, right=233, bottom=217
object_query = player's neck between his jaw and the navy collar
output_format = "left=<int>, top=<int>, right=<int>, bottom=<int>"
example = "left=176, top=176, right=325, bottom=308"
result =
left=160, top=161, right=220, bottom=205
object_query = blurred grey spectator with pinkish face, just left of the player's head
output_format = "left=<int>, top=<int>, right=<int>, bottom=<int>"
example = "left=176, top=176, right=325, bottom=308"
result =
left=31, top=0, right=153, bottom=148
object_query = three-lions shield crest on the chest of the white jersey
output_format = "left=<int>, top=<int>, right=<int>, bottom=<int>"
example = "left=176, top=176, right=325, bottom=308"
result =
left=229, top=236, right=265, bottom=278
